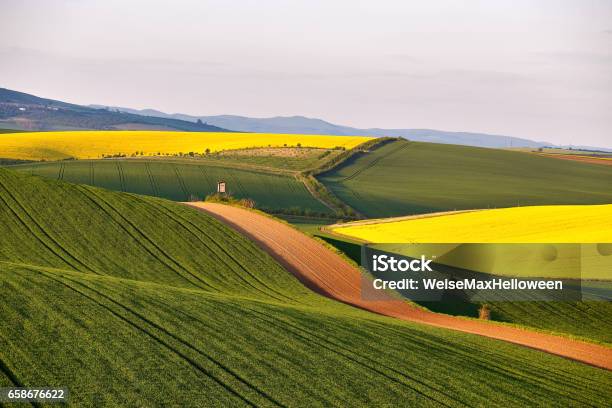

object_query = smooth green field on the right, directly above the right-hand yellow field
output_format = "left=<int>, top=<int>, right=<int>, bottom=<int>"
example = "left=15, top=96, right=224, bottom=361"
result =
left=318, top=141, right=612, bottom=217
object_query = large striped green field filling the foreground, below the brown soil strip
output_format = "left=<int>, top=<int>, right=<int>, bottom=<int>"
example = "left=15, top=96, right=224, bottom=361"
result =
left=0, top=169, right=612, bottom=406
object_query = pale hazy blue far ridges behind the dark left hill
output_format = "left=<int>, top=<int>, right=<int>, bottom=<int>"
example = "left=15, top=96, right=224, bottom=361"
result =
left=91, top=105, right=552, bottom=148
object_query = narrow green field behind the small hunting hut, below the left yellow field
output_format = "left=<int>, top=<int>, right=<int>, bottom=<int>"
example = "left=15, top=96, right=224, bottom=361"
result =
left=11, top=159, right=330, bottom=213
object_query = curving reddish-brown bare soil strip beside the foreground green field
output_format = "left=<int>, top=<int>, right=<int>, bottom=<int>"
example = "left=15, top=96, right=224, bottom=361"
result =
left=186, top=203, right=612, bottom=370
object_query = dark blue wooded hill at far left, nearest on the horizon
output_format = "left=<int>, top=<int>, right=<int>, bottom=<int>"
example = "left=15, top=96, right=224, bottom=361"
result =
left=0, top=88, right=225, bottom=132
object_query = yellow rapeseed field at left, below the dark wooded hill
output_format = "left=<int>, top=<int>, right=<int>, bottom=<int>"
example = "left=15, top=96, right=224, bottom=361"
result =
left=0, top=131, right=371, bottom=160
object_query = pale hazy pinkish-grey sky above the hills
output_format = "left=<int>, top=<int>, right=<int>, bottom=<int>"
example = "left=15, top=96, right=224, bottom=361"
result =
left=0, top=0, right=612, bottom=147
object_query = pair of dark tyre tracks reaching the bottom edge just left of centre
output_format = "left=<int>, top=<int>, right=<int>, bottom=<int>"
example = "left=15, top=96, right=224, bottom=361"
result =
left=41, top=272, right=284, bottom=407
